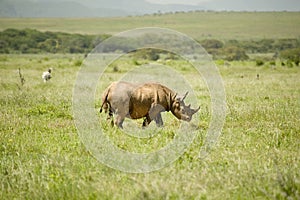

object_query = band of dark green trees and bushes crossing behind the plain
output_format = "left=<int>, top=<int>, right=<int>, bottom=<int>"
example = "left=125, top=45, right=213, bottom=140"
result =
left=0, top=29, right=300, bottom=65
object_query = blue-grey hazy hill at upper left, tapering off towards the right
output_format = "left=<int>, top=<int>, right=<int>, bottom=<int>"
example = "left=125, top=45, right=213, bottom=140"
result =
left=0, top=0, right=204, bottom=18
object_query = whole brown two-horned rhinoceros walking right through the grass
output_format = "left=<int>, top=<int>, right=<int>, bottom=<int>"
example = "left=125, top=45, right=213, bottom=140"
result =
left=100, top=81, right=200, bottom=128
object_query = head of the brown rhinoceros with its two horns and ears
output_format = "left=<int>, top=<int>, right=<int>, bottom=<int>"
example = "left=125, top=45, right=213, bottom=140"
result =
left=171, top=92, right=200, bottom=122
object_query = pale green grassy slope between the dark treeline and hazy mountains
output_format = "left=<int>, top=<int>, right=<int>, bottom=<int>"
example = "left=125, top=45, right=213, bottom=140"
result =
left=0, top=12, right=300, bottom=40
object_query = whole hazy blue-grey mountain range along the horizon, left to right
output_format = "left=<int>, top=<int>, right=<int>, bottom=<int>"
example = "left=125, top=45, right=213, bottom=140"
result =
left=0, top=0, right=300, bottom=17
